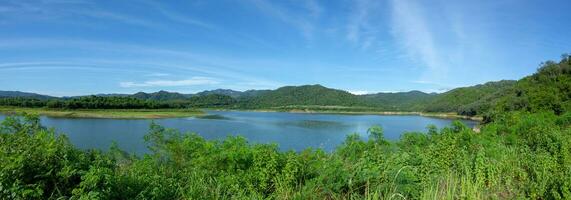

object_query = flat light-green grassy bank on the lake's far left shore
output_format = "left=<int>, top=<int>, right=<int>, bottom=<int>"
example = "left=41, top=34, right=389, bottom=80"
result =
left=0, top=107, right=204, bottom=119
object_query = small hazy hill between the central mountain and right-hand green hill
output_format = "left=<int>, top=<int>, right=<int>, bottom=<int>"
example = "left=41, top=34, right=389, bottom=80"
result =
left=361, top=90, right=438, bottom=111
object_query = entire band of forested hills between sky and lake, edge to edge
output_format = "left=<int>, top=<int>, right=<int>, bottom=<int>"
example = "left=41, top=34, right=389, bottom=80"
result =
left=0, top=55, right=571, bottom=120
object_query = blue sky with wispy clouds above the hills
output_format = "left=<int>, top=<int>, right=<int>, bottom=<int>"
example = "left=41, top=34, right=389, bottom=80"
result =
left=0, top=0, right=571, bottom=96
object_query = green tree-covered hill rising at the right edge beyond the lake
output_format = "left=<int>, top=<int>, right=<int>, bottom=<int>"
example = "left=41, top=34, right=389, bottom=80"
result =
left=424, top=55, right=571, bottom=116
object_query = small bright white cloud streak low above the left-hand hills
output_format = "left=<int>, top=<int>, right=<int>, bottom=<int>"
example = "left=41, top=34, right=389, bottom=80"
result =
left=119, top=76, right=220, bottom=88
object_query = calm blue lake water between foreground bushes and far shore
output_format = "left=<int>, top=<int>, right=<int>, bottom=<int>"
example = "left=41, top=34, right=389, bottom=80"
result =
left=0, top=111, right=477, bottom=154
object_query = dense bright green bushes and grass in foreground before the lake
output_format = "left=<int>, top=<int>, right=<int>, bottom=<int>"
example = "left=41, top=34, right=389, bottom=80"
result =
left=0, top=112, right=571, bottom=199
